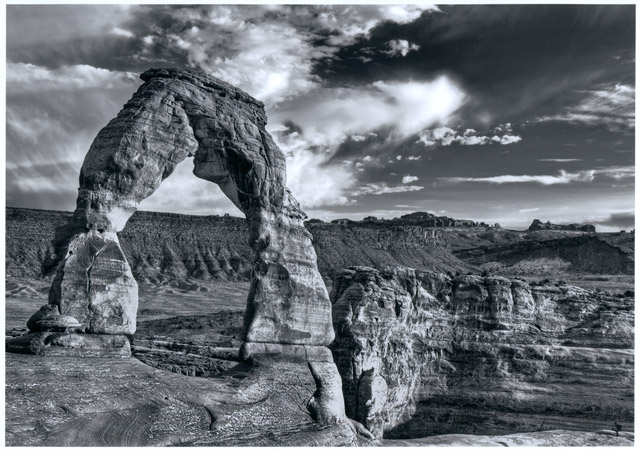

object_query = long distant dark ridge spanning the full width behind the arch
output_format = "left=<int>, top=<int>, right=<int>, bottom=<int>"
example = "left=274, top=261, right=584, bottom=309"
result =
left=6, top=208, right=635, bottom=289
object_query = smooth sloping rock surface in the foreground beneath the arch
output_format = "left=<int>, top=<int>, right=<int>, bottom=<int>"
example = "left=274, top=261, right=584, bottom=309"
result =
left=5, top=353, right=358, bottom=447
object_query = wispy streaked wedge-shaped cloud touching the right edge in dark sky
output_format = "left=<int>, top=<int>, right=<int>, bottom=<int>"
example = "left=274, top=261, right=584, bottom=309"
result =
left=537, top=84, right=636, bottom=131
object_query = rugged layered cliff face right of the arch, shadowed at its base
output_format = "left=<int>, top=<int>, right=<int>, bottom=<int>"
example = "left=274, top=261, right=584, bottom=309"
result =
left=331, top=267, right=634, bottom=438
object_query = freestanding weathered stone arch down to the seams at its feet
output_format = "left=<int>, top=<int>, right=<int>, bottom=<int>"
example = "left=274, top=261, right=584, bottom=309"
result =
left=50, top=69, right=333, bottom=346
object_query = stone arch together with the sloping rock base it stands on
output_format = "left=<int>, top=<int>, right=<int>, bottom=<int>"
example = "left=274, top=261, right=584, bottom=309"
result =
left=5, top=69, right=356, bottom=446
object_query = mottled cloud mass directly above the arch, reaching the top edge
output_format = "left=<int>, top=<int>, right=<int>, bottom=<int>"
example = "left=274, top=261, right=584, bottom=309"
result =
left=120, top=5, right=437, bottom=106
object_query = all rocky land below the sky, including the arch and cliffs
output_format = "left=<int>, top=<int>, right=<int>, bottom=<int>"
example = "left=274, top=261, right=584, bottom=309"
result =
left=5, top=64, right=634, bottom=446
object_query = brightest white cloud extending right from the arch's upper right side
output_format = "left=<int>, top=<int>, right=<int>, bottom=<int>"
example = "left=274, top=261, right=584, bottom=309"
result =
left=267, top=76, right=465, bottom=208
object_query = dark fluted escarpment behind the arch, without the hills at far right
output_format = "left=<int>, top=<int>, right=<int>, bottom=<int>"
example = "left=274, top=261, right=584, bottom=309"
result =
left=6, top=208, right=467, bottom=285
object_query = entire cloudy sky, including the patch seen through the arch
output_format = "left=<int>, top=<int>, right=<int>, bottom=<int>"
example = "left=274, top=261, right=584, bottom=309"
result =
left=6, top=5, right=635, bottom=231
